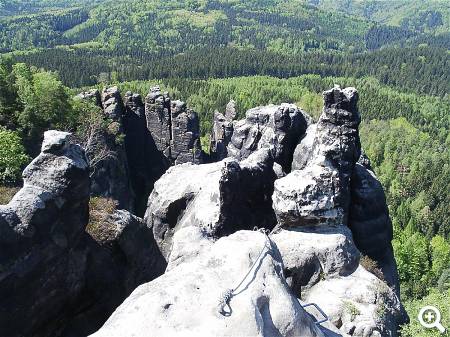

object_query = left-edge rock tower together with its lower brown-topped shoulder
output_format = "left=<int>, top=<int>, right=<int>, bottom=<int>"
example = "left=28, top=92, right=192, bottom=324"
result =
left=0, top=131, right=165, bottom=337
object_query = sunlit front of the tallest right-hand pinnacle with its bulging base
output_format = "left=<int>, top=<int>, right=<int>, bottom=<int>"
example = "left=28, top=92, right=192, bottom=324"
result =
left=273, top=88, right=361, bottom=226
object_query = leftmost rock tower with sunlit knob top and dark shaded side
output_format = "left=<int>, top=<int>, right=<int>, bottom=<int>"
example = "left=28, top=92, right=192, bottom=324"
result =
left=0, top=131, right=89, bottom=337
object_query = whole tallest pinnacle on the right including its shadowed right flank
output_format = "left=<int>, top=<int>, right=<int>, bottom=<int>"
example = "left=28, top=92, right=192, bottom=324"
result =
left=286, top=88, right=399, bottom=293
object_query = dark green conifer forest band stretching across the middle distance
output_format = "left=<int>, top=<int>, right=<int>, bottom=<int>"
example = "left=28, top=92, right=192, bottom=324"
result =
left=9, top=47, right=450, bottom=97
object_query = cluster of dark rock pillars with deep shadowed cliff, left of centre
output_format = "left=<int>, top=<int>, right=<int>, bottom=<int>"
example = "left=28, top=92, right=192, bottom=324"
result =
left=78, top=87, right=204, bottom=216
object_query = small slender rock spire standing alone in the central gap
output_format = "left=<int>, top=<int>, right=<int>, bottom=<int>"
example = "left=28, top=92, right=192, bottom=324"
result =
left=210, top=100, right=236, bottom=161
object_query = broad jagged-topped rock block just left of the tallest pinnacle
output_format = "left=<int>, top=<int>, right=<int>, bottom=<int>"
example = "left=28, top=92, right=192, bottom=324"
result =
left=228, top=104, right=309, bottom=172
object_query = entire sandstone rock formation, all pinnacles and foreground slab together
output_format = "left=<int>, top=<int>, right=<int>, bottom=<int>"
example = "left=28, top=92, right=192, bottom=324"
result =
left=0, top=87, right=405, bottom=337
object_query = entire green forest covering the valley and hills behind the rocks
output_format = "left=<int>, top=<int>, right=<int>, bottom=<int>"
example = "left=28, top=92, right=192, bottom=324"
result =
left=0, top=0, right=450, bottom=337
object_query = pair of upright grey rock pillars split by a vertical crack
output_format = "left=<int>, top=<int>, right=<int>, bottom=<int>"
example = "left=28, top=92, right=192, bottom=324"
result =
left=145, top=87, right=203, bottom=164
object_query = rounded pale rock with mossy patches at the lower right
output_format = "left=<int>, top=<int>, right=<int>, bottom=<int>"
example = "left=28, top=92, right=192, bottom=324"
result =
left=302, top=266, right=404, bottom=337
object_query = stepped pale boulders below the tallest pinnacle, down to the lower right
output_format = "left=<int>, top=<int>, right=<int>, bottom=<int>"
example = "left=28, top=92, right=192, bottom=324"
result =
left=272, top=225, right=404, bottom=337
